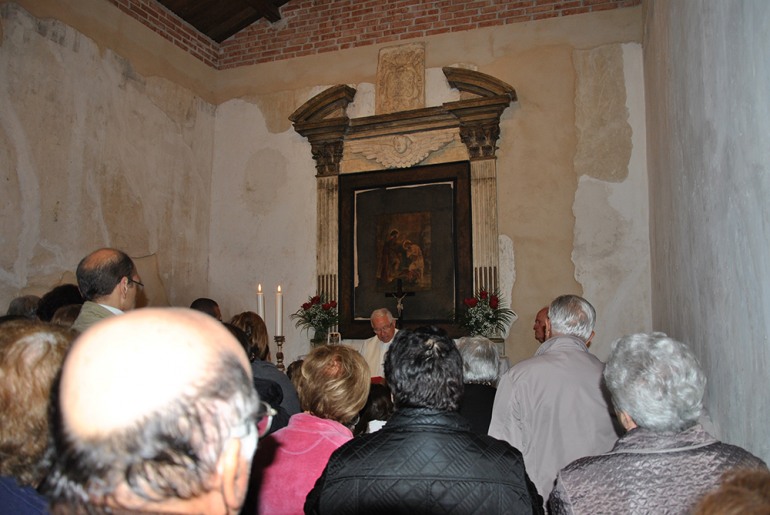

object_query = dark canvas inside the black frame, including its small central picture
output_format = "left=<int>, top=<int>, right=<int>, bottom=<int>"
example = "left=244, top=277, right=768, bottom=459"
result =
left=354, top=182, right=455, bottom=321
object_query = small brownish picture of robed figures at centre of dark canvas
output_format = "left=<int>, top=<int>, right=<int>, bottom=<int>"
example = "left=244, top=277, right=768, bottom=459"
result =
left=375, top=211, right=432, bottom=293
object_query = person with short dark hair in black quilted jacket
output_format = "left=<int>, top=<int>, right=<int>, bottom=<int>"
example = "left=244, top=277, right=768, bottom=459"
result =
left=305, top=328, right=542, bottom=515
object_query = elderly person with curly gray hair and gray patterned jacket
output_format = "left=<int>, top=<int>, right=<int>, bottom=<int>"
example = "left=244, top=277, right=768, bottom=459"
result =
left=549, top=333, right=766, bottom=514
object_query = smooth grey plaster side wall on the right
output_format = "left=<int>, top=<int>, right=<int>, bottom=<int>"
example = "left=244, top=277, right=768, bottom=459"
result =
left=644, top=0, right=770, bottom=461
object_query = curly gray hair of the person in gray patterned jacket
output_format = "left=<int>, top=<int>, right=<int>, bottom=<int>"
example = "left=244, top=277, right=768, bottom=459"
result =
left=604, top=333, right=706, bottom=431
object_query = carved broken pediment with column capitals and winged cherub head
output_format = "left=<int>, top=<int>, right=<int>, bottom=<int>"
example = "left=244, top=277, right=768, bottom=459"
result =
left=289, top=67, right=516, bottom=176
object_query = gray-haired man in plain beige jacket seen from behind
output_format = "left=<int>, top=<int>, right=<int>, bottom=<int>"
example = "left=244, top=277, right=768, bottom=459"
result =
left=489, top=295, right=618, bottom=499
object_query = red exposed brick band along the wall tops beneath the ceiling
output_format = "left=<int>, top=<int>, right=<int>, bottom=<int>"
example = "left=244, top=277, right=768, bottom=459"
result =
left=110, top=0, right=642, bottom=69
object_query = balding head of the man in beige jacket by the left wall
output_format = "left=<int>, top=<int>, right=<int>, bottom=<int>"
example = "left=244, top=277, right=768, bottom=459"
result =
left=76, top=248, right=136, bottom=301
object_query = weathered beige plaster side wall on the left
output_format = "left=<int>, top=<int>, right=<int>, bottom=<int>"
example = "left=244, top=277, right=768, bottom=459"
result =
left=0, top=4, right=214, bottom=309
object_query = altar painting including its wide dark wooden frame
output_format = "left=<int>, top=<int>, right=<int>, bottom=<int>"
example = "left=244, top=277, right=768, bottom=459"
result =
left=339, top=162, right=472, bottom=338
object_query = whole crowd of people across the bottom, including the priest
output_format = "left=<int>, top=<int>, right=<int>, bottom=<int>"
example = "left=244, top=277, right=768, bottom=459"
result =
left=0, top=249, right=770, bottom=515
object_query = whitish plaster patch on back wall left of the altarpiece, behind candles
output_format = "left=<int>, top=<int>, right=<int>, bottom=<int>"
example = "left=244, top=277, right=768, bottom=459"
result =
left=209, top=98, right=317, bottom=365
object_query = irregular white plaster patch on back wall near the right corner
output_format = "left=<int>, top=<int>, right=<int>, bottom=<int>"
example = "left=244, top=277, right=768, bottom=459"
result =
left=572, top=43, right=652, bottom=361
